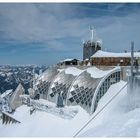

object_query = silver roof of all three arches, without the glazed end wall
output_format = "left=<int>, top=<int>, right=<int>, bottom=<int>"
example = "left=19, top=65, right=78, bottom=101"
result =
left=33, top=66, right=120, bottom=113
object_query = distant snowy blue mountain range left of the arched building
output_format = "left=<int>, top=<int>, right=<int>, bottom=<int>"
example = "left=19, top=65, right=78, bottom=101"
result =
left=0, top=65, right=47, bottom=94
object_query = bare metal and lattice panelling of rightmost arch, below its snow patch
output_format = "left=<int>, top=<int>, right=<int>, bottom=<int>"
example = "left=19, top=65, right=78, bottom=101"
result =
left=67, top=71, right=101, bottom=112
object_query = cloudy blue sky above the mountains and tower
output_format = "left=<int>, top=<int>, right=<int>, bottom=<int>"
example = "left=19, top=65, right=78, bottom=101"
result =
left=0, top=3, right=140, bottom=65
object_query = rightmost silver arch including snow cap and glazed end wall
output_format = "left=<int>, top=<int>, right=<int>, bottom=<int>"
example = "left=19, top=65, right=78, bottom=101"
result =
left=67, top=67, right=120, bottom=114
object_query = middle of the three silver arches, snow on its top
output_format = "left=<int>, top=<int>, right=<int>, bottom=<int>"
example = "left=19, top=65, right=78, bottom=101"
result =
left=48, top=67, right=82, bottom=102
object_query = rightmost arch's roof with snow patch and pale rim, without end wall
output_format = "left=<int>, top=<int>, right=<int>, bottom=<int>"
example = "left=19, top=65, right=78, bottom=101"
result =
left=67, top=67, right=120, bottom=113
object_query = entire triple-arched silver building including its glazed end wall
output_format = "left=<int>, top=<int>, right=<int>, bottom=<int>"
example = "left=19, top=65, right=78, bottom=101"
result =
left=29, top=66, right=120, bottom=114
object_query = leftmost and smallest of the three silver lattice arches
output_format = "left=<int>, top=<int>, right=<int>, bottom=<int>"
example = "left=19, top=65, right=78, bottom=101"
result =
left=35, top=67, right=59, bottom=99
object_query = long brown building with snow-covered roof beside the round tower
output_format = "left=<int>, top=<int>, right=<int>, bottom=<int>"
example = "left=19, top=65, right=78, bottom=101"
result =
left=89, top=50, right=140, bottom=66
